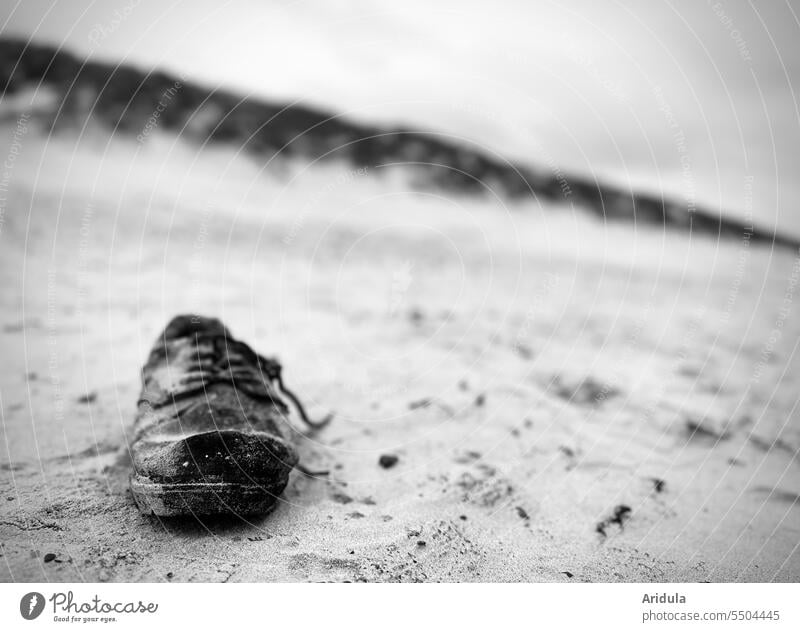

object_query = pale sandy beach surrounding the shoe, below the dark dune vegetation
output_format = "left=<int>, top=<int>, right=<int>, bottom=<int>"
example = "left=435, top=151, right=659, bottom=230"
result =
left=0, top=124, right=800, bottom=582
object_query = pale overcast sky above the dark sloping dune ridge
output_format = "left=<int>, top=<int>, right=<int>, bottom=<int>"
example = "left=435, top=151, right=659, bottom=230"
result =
left=0, top=0, right=800, bottom=235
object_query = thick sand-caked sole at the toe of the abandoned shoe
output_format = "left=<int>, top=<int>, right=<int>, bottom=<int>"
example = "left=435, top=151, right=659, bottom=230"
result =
left=130, top=475, right=277, bottom=517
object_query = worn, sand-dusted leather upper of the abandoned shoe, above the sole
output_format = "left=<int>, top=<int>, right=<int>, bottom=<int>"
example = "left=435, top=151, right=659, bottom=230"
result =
left=132, top=316, right=298, bottom=489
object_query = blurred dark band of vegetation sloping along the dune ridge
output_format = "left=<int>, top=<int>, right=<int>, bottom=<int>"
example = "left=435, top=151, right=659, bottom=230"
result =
left=0, top=40, right=797, bottom=247
